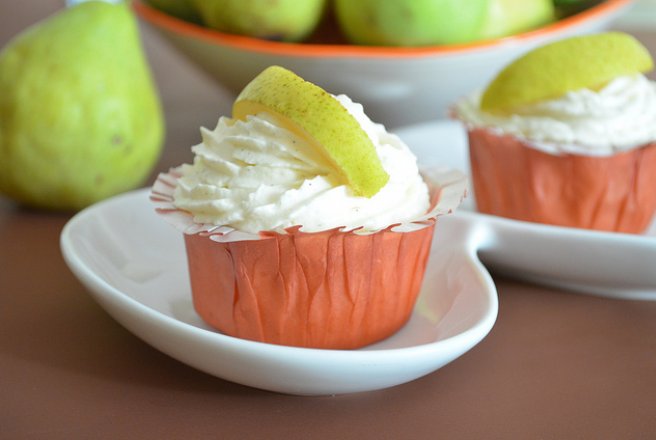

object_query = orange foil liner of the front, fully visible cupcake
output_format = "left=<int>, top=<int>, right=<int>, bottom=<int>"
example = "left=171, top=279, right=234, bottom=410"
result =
left=151, top=170, right=466, bottom=349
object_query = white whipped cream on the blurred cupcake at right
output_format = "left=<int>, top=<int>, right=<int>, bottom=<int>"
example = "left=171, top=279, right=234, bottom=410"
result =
left=455, top=75, right=656, bottom=156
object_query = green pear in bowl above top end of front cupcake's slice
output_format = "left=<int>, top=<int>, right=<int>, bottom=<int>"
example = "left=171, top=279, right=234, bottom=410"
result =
left=192, top=0, right=326, bottom=41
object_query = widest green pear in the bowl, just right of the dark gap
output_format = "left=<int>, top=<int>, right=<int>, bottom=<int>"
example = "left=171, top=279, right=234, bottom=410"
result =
left=335, top=0, right=488, bottom=46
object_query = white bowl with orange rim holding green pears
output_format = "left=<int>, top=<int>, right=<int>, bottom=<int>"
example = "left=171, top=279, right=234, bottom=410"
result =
left=133, top=0, right=633, bottom=128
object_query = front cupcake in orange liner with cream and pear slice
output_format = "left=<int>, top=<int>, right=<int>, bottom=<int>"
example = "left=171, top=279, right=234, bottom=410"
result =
left=151, top=66, right=465, bottom=349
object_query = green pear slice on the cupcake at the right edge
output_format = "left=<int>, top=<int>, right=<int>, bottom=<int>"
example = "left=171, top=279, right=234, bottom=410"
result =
left=481, top=32, right=654, bottom=113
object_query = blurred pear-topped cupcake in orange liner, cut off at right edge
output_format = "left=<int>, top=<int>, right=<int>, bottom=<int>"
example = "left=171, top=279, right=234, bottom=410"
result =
left=452, top=32, right=656, bottom=233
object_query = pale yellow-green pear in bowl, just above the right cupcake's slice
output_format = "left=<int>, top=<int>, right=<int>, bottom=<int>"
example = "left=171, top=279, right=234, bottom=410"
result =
left=481, top=0, right=556, bottom=39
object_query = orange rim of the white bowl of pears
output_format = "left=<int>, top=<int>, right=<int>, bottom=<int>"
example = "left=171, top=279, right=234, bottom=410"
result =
left=132, top=0, right=634, bottom=58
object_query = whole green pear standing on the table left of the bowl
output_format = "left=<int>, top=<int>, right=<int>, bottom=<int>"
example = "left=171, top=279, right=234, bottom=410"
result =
left=0, top=1, right=163, bottom=209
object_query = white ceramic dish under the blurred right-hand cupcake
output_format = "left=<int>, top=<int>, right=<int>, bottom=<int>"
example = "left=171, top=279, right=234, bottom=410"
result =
left=397, top=121, right=656, bottom=300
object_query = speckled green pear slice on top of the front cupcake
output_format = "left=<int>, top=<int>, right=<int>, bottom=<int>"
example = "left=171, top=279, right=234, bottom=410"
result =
left=232, top=66, right=389, bottom=197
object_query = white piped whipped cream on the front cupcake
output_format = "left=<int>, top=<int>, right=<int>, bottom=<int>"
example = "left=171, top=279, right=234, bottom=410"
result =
left=173, top=95, right=429, bottom=233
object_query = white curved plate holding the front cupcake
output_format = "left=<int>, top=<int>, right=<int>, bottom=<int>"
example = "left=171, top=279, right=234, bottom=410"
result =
left=61, top=190, right=498, bottom=395
